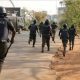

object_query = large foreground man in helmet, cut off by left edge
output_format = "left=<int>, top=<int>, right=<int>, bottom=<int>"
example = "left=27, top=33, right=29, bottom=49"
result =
left=0, top=7, right=15, bottom=71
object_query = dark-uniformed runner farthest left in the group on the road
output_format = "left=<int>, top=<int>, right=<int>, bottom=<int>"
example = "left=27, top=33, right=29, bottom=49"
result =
left=28, top=20, right=38, bottom=47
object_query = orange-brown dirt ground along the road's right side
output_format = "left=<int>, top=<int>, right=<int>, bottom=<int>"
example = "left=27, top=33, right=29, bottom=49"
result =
left=50, top=39, right=80, bottom=80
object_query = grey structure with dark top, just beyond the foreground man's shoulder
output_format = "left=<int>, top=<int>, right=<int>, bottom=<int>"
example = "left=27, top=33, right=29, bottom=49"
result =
left=5, top=7, right=24, bottom=31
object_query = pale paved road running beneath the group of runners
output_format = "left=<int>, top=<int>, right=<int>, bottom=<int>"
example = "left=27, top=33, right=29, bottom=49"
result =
left=0, top=32, right=60, bottom=80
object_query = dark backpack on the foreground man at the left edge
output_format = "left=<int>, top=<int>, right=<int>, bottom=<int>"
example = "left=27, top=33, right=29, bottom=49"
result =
left=0, top=18, right=8, bottom=42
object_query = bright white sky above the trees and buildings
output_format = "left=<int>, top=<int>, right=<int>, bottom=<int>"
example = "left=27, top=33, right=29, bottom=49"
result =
left=0, top=0, right=60, bottom=15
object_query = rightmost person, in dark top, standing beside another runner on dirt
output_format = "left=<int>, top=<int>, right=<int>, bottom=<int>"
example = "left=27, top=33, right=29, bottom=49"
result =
left=68, top=25, right=77, bottom=50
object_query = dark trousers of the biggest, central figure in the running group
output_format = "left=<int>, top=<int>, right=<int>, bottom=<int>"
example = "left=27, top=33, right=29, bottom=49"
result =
left=42, top=35, right=50, bottom=52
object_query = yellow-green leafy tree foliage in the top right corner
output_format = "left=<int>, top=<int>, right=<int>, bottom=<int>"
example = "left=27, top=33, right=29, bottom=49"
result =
left=62, top=0, right=80, bottom=27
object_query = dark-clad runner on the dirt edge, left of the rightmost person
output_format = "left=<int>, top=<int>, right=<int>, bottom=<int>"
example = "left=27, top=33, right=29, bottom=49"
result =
left=59, top=24, right=69, bottom=57
